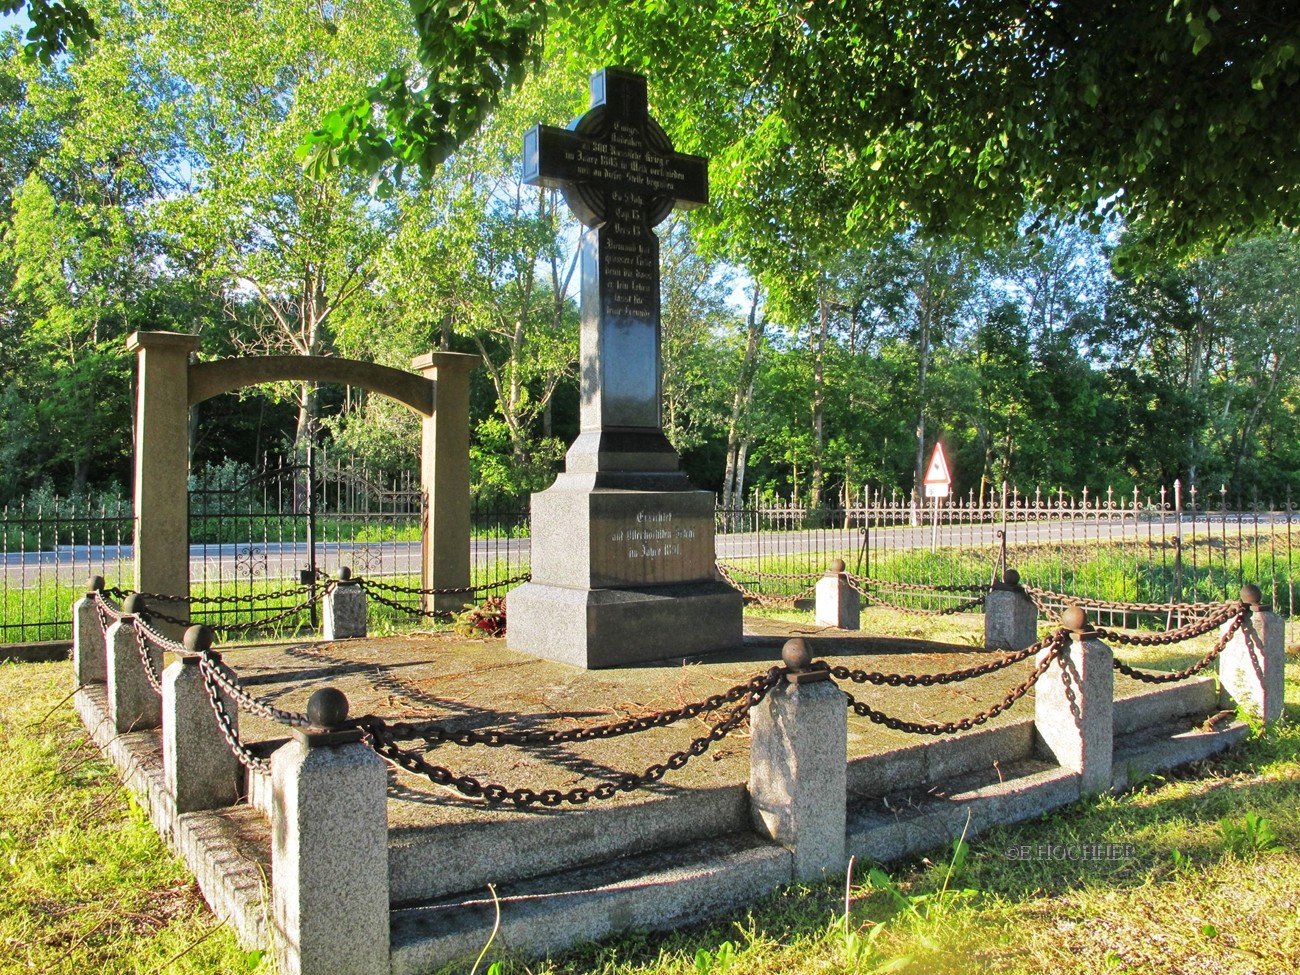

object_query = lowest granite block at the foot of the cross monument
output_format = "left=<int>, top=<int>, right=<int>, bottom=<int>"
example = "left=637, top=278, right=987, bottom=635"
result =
left=506, top=582, right=744, bottom=670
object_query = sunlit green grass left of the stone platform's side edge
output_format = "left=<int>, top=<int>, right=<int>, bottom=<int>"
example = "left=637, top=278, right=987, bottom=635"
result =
left=0, top=664, right=255, bottom=975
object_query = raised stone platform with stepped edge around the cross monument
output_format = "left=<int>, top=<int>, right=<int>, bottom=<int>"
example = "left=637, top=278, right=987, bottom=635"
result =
left=77, top=620, right=1244, bottom=972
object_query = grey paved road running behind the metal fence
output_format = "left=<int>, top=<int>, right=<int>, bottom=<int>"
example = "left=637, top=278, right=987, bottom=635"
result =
left=0, top=514, right=1281, bottom=589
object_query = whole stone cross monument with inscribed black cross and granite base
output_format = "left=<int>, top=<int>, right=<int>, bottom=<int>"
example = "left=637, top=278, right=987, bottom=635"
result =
left=507, top=68, right=741, bottom=667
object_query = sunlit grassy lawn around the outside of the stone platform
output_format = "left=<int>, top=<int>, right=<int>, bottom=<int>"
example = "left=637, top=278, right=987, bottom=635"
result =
left=0, top=616, right=1300, bottom=975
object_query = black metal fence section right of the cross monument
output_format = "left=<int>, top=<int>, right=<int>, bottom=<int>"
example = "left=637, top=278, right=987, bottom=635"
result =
left=716, top=482, right=1300, bottom=615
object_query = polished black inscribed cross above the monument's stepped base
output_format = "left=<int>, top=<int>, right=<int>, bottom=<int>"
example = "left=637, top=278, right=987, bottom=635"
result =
left=524, top=68, right=709, bottom=441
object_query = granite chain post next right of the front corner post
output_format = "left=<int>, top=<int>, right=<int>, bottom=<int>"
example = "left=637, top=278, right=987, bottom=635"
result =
left=749, top=657, right=849, bottom=883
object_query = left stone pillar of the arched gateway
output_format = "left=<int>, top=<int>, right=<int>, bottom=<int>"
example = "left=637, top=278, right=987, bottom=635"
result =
left=126, top=332, right=199, bottom=636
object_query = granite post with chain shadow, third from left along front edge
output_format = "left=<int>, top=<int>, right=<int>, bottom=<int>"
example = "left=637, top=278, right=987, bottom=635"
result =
left=1034, top=618, right=1115, bottom=796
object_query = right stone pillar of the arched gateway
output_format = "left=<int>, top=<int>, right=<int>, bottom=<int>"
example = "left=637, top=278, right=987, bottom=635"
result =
left=411, top=352, right=480, bottom=611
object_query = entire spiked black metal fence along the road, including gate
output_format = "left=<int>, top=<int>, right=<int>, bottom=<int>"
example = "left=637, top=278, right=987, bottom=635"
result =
left=0, top=478, right=1300, bottom=642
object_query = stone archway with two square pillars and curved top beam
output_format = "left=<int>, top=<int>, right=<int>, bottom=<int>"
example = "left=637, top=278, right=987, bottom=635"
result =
left=126, top=332, right=478, bottom=626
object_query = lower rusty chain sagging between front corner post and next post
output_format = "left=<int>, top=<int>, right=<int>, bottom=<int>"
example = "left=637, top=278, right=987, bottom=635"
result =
left=361, top=667, right=784, bottom=809
